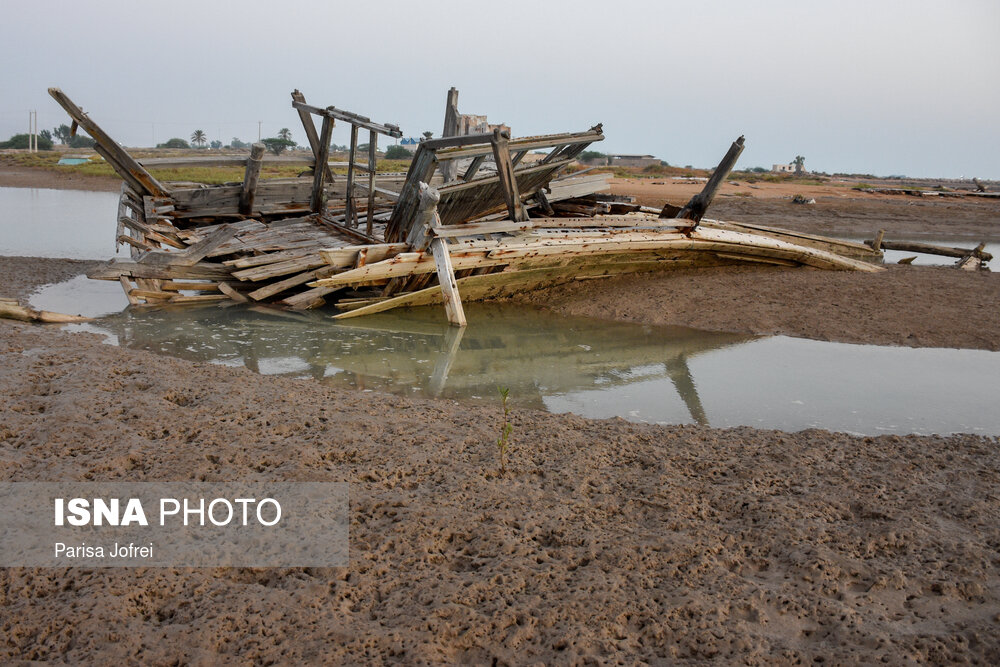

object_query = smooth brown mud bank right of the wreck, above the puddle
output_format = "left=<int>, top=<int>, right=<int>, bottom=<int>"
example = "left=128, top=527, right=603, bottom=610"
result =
left=516, top=265, right=1000, bottom=350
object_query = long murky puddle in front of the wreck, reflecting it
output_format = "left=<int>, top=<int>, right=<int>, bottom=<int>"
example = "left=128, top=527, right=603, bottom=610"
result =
left=32, top=280, right=1000, bottom=435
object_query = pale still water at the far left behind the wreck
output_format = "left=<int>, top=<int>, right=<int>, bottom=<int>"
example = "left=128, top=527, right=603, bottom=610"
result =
left=0, top=188, right=118, bottom=259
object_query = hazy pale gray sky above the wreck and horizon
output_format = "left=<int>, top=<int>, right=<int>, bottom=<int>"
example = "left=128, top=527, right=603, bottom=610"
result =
left=0, top=0, right=1000, bottom=179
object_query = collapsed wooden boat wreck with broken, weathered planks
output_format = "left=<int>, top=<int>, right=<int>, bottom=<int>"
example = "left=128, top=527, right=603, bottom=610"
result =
left=49, top=88, right=881, bottom=326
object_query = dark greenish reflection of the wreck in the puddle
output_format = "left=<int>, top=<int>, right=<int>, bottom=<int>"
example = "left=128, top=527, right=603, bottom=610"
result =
left=99, top=304, right=753, bottom=424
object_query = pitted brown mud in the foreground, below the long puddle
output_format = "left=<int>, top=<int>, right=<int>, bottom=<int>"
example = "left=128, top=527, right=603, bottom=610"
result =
left=0, top=322, right=1000, bottom=664
